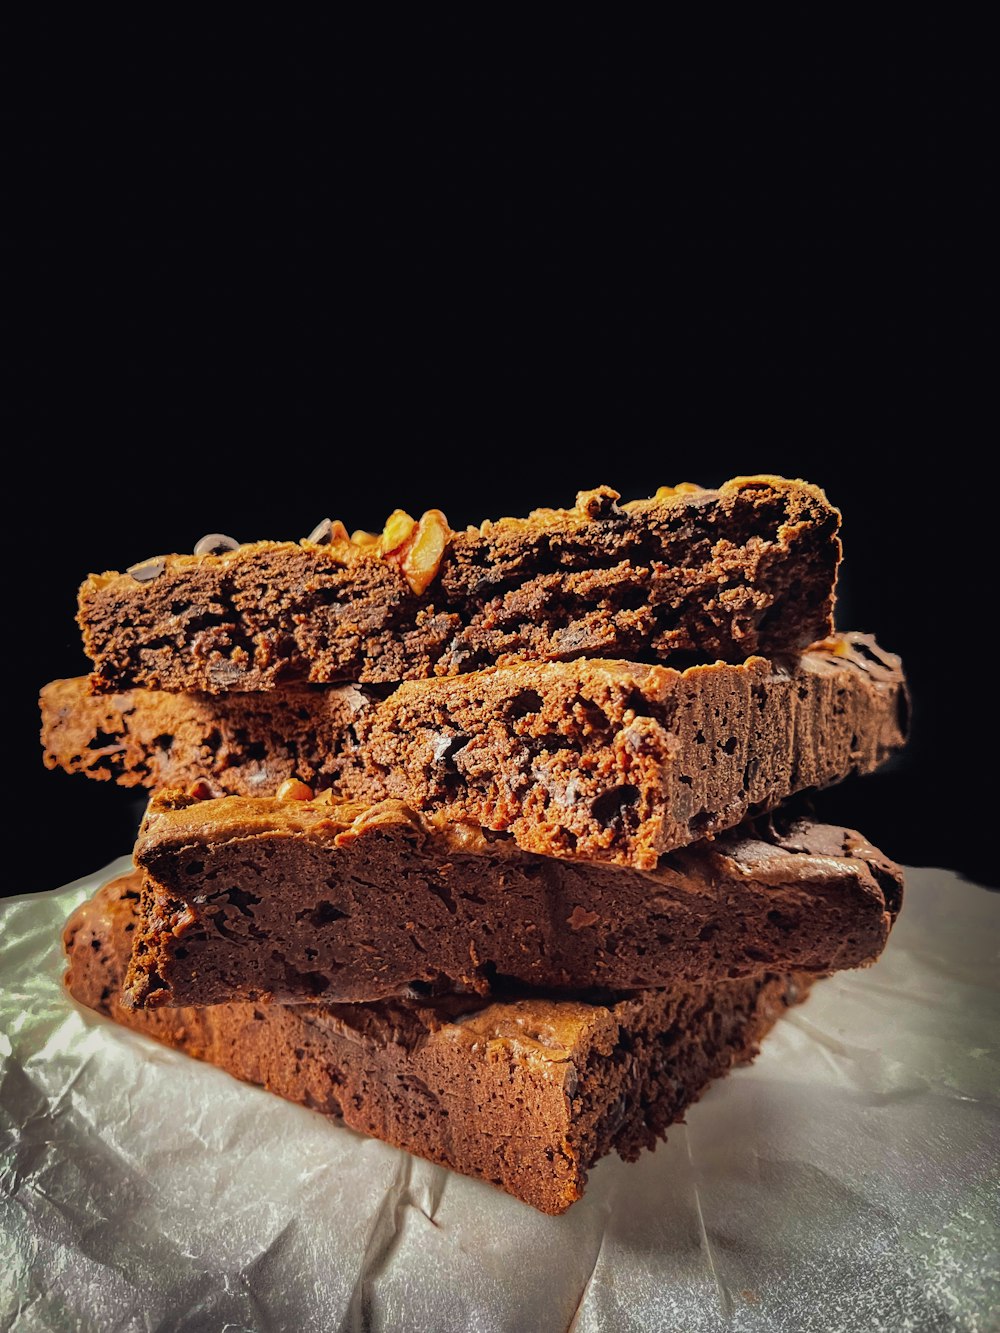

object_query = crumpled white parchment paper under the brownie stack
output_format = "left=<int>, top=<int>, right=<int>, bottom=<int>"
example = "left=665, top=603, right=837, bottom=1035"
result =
left=0, top=861, right=1000, bottom=1333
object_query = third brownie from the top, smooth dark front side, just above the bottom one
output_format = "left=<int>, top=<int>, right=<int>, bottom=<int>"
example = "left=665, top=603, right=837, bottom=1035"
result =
left=125, top=792, right=903, bottom=1006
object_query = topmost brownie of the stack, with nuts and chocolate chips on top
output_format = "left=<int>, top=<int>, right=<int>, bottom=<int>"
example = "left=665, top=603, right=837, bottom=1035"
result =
left=79, top=477, right=840, bottom=693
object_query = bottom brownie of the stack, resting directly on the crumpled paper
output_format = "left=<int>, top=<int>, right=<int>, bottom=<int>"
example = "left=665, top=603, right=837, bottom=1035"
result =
left=64, top=876, right=809, bottom=1213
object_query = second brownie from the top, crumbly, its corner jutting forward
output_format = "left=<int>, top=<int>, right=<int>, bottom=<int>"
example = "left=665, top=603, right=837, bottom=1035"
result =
left=41, top=635, right=907, bottom=869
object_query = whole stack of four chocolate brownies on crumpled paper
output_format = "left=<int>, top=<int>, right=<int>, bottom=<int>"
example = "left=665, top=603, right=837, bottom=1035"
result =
left=41, top=477, right=907, bottom=1213
